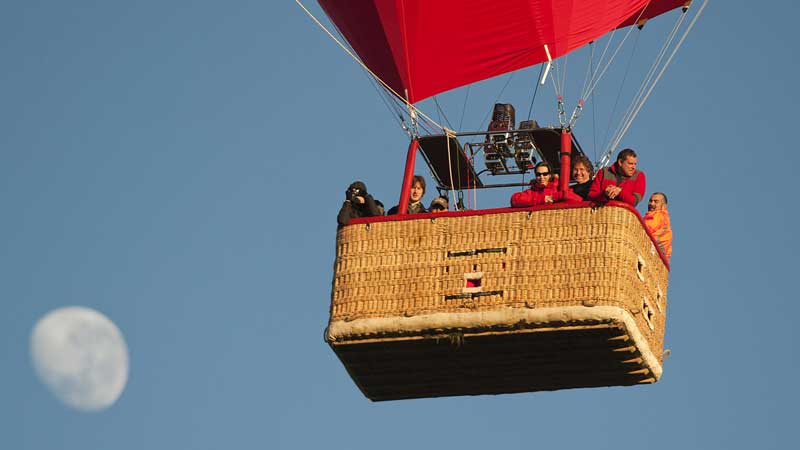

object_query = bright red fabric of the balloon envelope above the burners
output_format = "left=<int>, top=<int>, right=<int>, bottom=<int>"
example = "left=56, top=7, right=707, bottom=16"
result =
left=319, top=0, right=682, bottom=103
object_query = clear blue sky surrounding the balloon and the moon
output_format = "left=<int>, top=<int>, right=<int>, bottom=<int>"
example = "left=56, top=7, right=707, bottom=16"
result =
left=0, top=0, right=800, bottom=449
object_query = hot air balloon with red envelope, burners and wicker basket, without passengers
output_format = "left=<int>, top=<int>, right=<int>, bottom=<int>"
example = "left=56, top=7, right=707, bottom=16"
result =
left=298, top=0, right=706, bottom=401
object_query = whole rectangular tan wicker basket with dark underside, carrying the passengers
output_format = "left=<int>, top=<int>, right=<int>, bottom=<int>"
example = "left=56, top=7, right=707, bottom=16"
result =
left=326, top=205, right=669, bottom=400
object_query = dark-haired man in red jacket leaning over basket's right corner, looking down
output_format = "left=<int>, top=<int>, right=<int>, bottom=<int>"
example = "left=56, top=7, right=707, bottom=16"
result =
left=589, top=148, right=646, bottom=207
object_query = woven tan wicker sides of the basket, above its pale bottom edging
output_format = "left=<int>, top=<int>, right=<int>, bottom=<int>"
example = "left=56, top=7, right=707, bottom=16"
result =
left=331, top=206, right=668, bottom=360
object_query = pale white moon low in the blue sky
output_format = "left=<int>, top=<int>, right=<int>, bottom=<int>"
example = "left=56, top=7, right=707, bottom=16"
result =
left=30, top=306, right=128, bottom=411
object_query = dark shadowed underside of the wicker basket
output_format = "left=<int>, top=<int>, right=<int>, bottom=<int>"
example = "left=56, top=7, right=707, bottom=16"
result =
left=331, top=322, right=660, bottom=401
